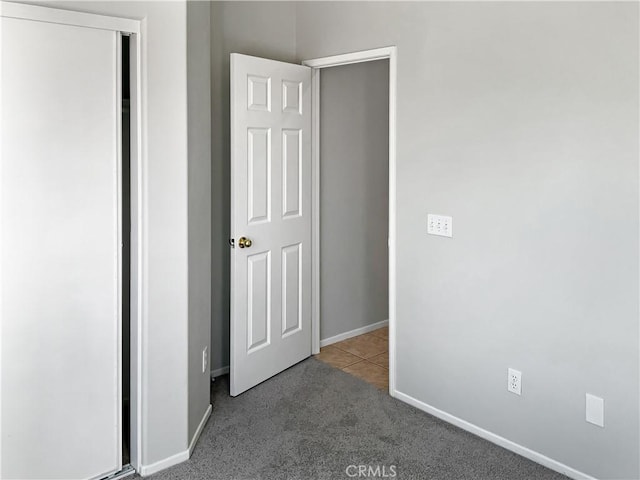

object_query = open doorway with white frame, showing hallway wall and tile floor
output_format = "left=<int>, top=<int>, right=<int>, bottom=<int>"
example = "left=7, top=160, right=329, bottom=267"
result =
left=303, top=47, right=396, bottom=396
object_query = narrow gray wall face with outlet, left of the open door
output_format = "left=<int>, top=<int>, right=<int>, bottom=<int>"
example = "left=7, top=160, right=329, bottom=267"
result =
left=187, top=1, right=211, bottom=439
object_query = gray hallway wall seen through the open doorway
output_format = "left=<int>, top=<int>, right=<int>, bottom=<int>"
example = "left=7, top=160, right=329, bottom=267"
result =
left=320, top=60, right=389, bottom=340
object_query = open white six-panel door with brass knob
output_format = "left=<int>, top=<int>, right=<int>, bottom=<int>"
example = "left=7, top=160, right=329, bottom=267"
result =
left=231, top=54, right=311, bottom=396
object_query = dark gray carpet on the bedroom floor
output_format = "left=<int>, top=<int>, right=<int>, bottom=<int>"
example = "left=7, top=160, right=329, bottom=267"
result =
left=151, top=358, right=566, bottom=480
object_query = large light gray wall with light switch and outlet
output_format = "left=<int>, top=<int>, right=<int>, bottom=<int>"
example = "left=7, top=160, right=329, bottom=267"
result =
left=296, top=2, right=640, bottom=478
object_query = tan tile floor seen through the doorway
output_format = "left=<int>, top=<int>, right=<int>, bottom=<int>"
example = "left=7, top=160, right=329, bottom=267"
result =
left=316, top=327, right=389, bottom=391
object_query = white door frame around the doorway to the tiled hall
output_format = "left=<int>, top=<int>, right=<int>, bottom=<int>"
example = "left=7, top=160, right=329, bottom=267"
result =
left=302, top=46, right=398, bottom=396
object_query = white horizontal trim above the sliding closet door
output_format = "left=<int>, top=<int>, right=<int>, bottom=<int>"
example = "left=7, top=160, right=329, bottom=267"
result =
left=0, top=2, right=140, bottom=33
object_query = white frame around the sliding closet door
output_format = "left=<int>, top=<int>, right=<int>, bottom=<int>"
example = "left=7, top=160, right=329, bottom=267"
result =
left=0, top=1, right=148, bottom=475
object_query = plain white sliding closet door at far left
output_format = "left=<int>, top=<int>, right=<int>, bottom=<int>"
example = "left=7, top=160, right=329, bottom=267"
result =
left=0, top=13, right=121, bottom=479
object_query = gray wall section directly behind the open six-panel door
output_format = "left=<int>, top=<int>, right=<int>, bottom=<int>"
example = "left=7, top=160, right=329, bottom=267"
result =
left=211, top=2, right=296, bottom=371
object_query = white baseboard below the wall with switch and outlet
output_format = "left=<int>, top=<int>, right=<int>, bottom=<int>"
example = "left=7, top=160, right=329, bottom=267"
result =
left=393, top=390, right=595, bottom=480
